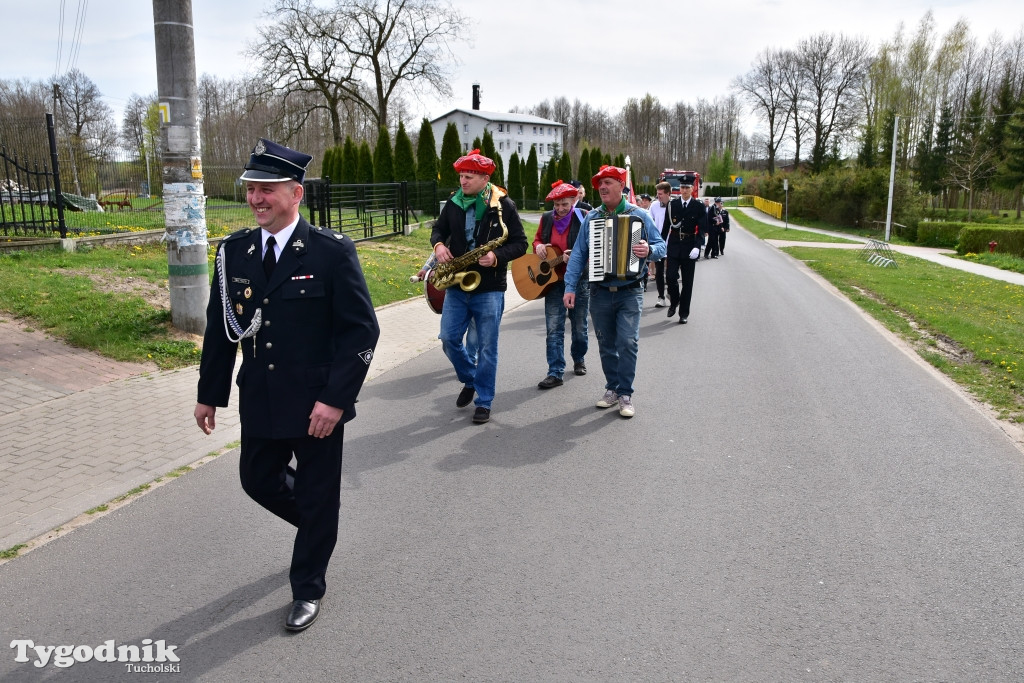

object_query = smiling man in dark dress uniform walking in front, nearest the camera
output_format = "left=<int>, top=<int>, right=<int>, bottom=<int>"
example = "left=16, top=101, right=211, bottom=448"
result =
left=195, top=139, right=380, bottom=631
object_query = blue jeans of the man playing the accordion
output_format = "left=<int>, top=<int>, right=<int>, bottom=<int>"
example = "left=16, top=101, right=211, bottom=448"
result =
left=590, top=285, right=643, bottom=396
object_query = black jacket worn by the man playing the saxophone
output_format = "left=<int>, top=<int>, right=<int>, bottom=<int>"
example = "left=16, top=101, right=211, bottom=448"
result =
left=430, top=185, right=526, bottom=292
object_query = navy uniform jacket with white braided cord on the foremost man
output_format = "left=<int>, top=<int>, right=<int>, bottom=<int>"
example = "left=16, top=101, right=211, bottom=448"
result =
left=198, top=218, right=380, bottom=438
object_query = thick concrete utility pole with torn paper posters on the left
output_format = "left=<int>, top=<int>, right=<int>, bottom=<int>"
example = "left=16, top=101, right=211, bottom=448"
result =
left=153, top=0, right=210, bottom=334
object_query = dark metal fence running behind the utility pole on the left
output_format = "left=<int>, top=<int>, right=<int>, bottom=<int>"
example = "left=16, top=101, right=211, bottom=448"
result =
left=0, top=115, right=438, bottom=240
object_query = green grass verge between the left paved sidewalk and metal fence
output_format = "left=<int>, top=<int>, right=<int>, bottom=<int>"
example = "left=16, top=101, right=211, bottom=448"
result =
left=0, top=222, right=537, bottom=369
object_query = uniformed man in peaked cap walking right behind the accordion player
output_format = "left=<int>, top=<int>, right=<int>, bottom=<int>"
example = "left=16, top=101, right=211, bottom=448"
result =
left=667, top=177, right=708, bottom=325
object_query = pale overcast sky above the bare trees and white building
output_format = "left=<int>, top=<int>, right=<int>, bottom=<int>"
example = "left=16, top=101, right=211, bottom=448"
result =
left=0, top=0, right=1024, bottom=138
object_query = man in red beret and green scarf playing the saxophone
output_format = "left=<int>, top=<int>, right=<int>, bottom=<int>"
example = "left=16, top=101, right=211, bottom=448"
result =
left=430, top=150, right=526, bottom=424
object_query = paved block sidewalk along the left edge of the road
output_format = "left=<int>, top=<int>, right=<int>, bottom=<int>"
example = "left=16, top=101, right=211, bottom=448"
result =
left=0, top=286, right=526, bottom=550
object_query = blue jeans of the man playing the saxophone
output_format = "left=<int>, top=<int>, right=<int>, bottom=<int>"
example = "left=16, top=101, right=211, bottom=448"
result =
left=437, top=287, right=505, bottom=409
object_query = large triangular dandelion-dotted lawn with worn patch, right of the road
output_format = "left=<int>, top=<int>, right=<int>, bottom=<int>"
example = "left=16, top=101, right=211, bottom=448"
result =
left=784, top=247, right=1024, bottom=422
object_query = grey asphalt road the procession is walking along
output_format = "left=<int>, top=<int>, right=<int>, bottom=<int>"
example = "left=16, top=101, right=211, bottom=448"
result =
left=0, top=229, right=1024, bottom=681
